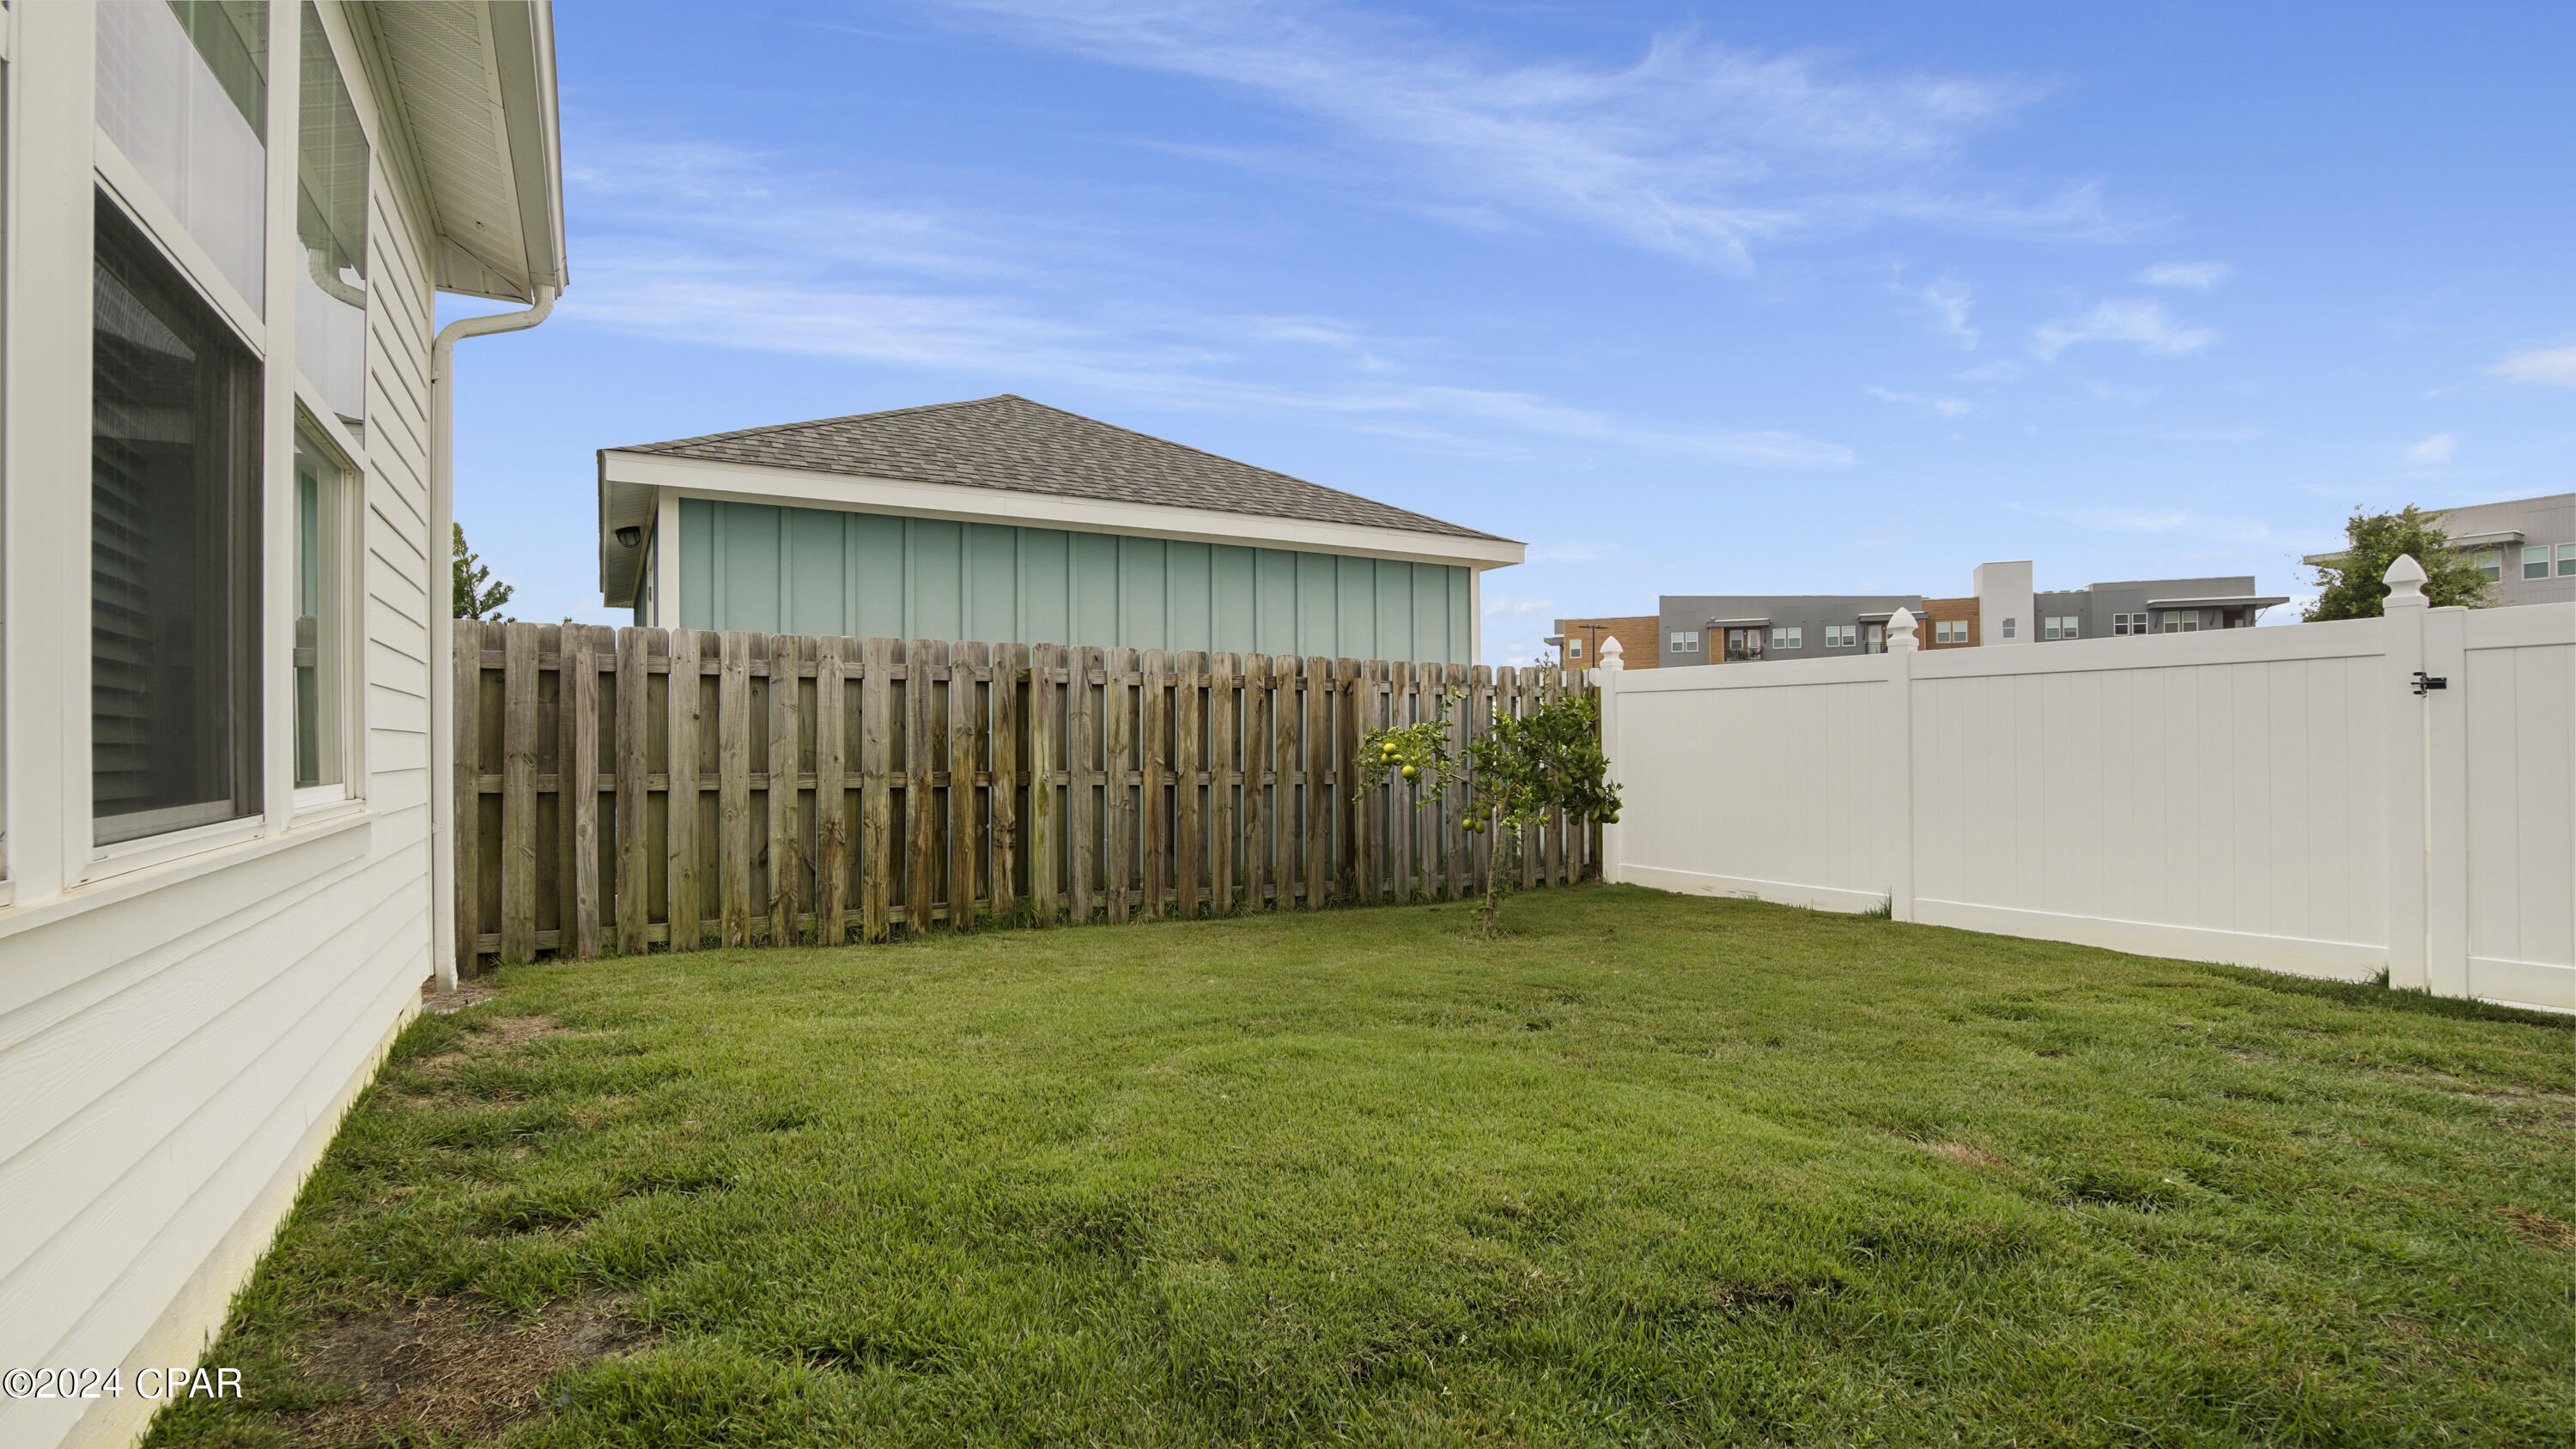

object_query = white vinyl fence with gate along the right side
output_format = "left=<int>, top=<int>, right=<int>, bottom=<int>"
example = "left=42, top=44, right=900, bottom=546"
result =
left=1595, top=561, right=2576, bottom=1011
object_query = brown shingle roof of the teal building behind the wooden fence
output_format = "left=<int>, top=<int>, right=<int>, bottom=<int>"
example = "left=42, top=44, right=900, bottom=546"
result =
left=616, top=394, right=1497, bottom=538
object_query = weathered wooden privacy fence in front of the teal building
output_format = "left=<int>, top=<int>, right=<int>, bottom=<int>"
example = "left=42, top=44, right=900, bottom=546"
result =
left=453, top=621, right=1600, bottom=970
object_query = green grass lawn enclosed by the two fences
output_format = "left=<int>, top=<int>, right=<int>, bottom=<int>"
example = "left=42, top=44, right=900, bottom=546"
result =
left=155, top=888, right=2576, bottom=1449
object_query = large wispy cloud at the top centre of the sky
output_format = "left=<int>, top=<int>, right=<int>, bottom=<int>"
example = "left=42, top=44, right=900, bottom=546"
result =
left=945, top=0, right=2115, bottom=270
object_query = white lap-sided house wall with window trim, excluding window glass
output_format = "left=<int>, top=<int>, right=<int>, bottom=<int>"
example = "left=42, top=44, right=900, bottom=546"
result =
left=0, top=0, right=487, bottom=1446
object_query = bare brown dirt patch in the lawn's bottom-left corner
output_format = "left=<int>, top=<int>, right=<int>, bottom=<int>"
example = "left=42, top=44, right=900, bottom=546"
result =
left=276, top=1297, right=652, bottom=1446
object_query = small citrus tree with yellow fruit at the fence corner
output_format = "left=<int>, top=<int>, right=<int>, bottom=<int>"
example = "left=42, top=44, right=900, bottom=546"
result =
left=1355, top=693, right=1618, bottom=934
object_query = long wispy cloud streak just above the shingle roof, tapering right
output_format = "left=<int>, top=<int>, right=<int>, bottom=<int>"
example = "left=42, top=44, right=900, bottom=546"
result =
left=562, top=149, right=1852, bottom=469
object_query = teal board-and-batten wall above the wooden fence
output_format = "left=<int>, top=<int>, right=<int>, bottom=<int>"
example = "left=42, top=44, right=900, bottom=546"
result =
left=675, top=500, right=1473, bottom=664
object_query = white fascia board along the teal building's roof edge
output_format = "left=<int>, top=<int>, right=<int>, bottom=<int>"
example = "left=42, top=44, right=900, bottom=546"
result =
left=600, top=448, right=1530, bottom=572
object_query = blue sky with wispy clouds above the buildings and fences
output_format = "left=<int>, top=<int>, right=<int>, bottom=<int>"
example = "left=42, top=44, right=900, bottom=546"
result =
left=456, top=0, right=2576, bottom=662
